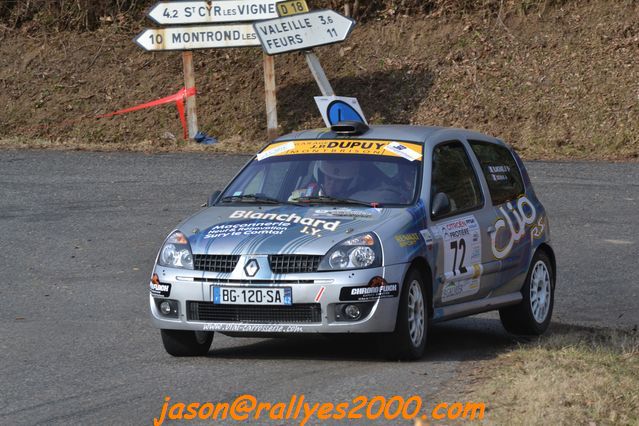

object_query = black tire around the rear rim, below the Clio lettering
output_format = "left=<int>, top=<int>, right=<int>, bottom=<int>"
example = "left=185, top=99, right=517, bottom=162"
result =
left=499, top=250, right=555, bottom=336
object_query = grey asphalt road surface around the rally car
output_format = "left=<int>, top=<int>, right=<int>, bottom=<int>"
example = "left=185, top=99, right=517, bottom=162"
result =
left=0, top=151, right=639, bottom=425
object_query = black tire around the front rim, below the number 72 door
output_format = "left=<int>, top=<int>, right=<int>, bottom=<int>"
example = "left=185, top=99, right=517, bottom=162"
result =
left=379, top=269, right=428, bottom=361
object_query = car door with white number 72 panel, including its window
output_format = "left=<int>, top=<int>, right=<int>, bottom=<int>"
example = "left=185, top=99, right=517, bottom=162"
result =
left=428, top=140, right=499, bottom=306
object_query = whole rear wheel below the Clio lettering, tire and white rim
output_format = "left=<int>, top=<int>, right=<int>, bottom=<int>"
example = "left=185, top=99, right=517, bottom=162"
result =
left=499, top=251, right=555, bottom=335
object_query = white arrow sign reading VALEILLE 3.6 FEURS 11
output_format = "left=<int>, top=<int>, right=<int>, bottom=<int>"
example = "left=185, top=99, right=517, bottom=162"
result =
left=253, top=10, right=355, bottom=55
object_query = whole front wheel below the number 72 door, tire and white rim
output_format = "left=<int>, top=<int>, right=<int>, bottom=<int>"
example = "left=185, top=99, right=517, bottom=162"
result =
left=380, top=269, right=428, bottom=360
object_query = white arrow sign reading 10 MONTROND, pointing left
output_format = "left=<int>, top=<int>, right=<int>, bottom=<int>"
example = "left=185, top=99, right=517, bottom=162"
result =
left=133, top=24, right=260, bottom=50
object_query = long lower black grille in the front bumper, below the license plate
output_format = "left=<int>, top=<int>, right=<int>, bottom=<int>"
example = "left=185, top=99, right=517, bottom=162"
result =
left=187, top=302, right=322, bottom=324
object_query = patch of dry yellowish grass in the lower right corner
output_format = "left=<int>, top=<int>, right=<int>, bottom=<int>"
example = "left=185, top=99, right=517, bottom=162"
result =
left=471, top=329, right=639, bottom=425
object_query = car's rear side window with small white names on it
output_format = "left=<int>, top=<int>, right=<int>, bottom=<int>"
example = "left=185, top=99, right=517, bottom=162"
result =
left=469, top=141, right=524, bottom=205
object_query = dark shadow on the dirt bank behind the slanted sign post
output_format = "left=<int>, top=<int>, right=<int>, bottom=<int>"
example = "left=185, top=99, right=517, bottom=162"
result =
left=277, top=68, right=434, bottom=132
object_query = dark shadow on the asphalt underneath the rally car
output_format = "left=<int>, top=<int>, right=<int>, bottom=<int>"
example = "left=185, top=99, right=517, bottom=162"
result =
left=209, top=317, right=525, bottom=362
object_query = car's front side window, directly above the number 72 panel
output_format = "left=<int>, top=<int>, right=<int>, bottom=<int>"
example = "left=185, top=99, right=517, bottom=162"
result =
left=431, top=142, right=483, bottom=215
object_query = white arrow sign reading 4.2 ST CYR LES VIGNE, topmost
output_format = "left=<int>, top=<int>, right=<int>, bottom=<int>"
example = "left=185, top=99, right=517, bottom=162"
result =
left=147, top=0, right=278, bottom=25
